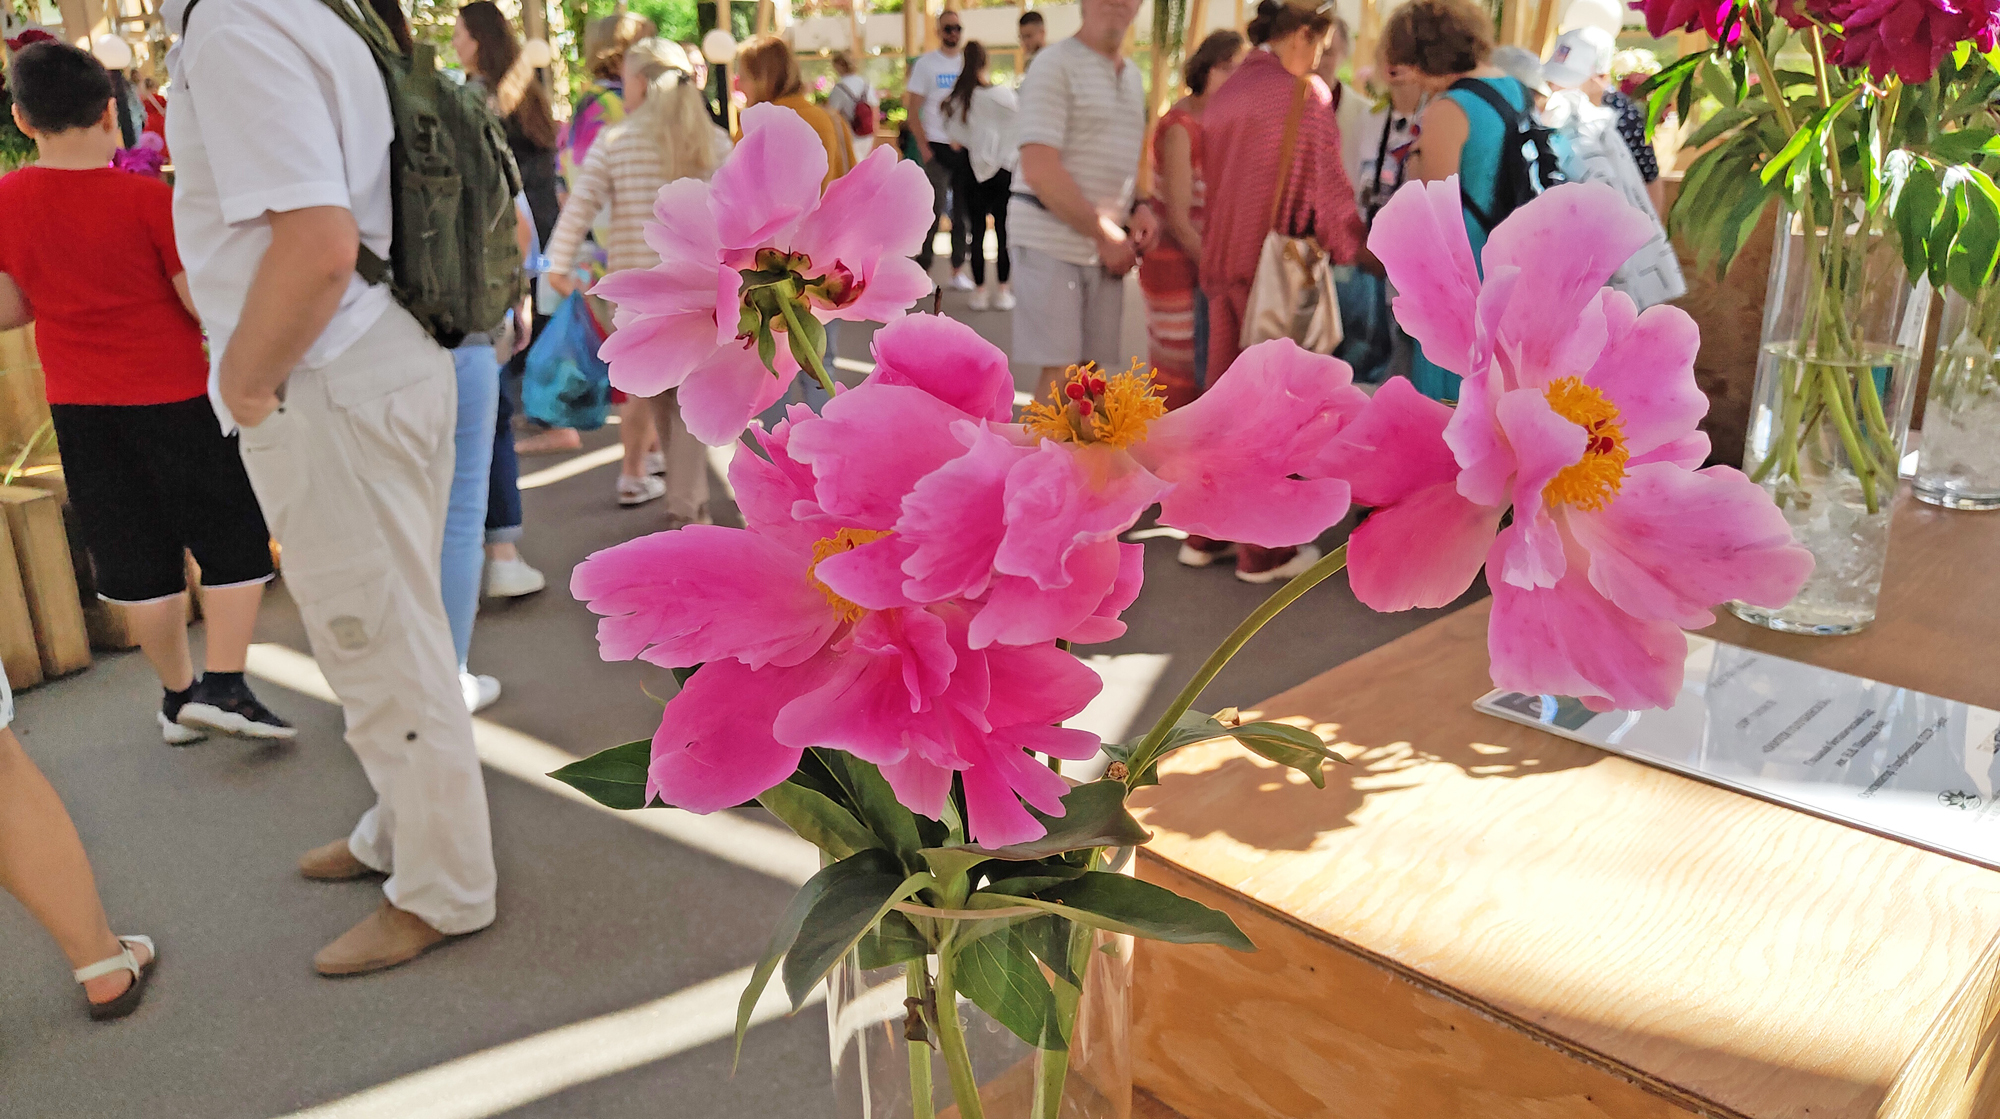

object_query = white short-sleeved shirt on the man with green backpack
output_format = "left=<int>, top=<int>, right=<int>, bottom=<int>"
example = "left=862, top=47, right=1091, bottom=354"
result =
left=162, top=0, right=396, bottom=432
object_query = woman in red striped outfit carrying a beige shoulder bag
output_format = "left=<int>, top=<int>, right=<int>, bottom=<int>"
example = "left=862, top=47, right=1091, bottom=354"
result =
left=1180, top=0, right=1368, bottom=583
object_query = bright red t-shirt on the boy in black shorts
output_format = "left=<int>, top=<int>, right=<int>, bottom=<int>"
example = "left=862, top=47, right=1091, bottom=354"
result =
left=0, top=166, right=208, bottom=404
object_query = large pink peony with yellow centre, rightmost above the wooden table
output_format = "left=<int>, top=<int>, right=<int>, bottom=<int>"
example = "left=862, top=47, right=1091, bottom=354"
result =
left=1322, top=178, right=1812, bottom=709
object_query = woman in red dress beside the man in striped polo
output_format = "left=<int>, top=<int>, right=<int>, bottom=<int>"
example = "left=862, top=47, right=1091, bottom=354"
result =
left=1138, top=32, right=1244, bottom=408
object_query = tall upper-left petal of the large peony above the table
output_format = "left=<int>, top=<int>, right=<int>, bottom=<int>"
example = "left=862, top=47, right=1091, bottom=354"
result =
left=1368, top=176, right=1480, bottom=376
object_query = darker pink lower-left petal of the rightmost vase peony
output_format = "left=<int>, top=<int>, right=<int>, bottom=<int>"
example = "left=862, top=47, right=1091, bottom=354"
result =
left=1348, top=482, right=1502, bottom=611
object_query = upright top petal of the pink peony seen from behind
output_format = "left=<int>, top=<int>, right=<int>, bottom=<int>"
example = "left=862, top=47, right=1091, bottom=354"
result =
left=708, top=102, right=826, bottom=252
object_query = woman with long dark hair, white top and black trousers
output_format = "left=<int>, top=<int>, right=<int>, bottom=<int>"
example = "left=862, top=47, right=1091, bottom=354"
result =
left=938, top=40, right=1020, bottom=312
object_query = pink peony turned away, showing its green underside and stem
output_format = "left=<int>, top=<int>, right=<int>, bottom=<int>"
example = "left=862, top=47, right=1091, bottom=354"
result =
left=592, top=104, right=932, bottom=446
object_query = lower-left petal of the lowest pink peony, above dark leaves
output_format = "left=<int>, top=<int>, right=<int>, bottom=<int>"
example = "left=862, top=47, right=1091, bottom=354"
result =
left=646, top=657, right=832, bottom=813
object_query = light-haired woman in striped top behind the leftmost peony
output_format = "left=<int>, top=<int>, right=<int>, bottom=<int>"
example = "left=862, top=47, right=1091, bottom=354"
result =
left=548, top=38, right=730, bottom=528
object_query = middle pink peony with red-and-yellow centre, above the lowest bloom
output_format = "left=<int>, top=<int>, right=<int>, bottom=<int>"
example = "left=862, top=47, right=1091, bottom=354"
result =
left=792, top=316, right=1368, bottom=649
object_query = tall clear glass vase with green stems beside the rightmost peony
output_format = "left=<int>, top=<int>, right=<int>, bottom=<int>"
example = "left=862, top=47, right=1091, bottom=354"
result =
left=1730, top=198, right=1930, bottom=633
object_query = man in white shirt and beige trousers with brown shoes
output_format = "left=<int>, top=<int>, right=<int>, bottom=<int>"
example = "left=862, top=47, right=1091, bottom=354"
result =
left=162, top=0, right=494, bottom=975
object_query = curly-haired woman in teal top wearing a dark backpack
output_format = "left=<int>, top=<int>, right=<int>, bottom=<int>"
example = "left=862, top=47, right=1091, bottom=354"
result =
left=1382, top=0, right=1534, bottom=404
